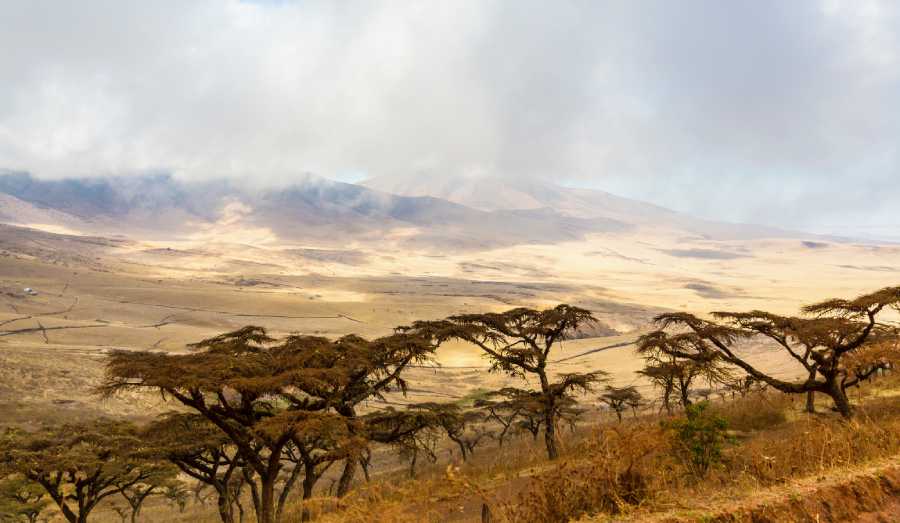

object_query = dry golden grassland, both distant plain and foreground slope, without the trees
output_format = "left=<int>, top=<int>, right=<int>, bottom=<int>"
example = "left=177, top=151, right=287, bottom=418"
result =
left=0, top=222, right=900, bottom=523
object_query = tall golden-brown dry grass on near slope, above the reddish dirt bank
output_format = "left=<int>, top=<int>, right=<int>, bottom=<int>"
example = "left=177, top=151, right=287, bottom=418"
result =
left=86, top=376, right=900, bottom=523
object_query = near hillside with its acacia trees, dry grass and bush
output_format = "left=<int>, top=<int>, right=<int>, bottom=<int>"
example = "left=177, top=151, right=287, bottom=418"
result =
left=0, top=287, right=900, bottom=523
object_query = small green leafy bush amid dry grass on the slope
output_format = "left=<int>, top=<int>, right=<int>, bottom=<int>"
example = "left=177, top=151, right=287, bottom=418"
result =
left=663, top=401, right=731, bottom=477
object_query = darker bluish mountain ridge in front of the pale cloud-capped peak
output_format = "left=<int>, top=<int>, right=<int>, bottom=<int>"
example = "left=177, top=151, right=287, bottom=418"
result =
left=0, top=173, right=630, bottom=249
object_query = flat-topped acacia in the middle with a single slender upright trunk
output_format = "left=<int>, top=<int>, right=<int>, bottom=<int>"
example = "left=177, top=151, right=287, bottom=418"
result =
left=412, top=304, right=605, bottom=459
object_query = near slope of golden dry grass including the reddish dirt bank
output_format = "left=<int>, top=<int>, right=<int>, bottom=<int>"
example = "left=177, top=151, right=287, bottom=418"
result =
left=75, top=374, right=900, bottom=523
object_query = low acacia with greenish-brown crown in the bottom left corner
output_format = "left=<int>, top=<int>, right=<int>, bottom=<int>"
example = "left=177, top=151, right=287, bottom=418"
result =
left=0, top=419, right=156, bottom=523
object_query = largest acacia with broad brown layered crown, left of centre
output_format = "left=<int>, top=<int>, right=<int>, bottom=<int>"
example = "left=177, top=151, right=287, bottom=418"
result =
left=100, top=326, right=366, bottom=523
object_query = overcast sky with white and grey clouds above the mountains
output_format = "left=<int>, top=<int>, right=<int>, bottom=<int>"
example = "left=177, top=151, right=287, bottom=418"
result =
left=0, top=0, right=900, bottom=236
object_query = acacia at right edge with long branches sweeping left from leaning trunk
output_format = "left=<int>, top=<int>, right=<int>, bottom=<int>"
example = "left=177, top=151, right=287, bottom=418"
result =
left=639, top=287, right=900, bottom=418
